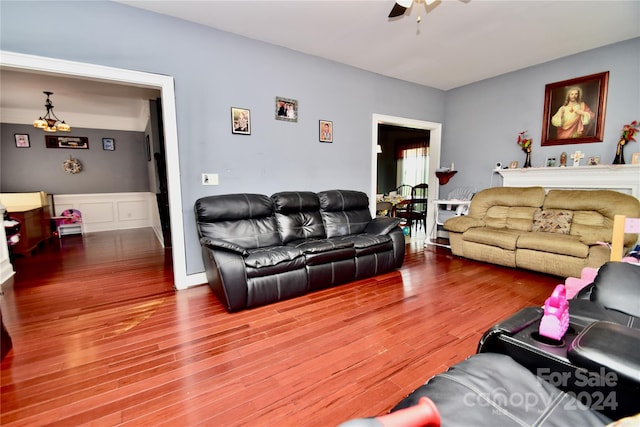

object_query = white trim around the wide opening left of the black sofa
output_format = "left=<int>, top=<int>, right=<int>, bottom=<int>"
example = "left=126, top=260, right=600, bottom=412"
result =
left=0, top=51, right=198, bottom=289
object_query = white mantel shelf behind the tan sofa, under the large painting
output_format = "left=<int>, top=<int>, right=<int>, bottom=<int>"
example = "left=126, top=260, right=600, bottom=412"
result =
left=494, top=165, right=640, bottom=199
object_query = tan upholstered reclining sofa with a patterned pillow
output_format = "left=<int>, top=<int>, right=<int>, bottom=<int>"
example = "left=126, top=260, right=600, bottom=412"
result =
left=444, top=187, right=640, bottom=277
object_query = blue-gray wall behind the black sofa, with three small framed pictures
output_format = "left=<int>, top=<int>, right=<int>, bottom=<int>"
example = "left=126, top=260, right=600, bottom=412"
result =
left=0, top=1, right=444, bottom=273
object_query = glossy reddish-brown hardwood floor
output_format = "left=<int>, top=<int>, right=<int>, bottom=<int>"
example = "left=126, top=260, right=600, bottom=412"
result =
left=0, top=229, right=561, bottom=426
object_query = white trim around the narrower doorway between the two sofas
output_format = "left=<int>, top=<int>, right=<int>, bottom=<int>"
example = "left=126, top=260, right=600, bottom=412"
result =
left=369, top=113, right=442, bottom=245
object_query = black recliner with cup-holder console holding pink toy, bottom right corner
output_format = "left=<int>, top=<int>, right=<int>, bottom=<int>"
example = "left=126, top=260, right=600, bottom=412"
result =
left=478, top=262, right=640, bottom=419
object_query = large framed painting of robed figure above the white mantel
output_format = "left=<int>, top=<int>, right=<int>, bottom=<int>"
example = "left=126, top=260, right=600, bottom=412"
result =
left=541, top=71, right=609, bottom=146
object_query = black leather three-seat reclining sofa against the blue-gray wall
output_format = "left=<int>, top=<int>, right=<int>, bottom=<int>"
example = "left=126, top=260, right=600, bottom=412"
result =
left=195, top=190, right=405, bottom=311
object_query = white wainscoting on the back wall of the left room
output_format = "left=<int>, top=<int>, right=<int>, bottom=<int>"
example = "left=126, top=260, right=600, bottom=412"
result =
left=53, top=192, right=162, bottom=236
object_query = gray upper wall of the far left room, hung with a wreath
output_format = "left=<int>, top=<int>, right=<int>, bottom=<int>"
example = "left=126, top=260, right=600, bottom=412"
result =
left=0, top=123, right=149, bottom=194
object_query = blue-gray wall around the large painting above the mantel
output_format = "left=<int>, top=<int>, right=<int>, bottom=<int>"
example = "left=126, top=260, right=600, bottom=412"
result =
left=441, top=38, right=640, bottom=194
